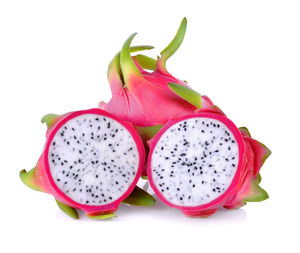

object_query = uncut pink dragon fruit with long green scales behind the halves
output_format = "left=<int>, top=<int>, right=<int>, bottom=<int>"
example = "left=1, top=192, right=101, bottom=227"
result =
left=99, top=18, right=212, bottom=127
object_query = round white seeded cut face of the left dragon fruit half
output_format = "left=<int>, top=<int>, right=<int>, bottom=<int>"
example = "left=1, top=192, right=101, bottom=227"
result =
left=44, top=109, right=144, bottom=210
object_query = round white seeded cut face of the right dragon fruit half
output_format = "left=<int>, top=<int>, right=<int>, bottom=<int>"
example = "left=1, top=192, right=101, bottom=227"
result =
left=148, top=113, right=244, bottom=207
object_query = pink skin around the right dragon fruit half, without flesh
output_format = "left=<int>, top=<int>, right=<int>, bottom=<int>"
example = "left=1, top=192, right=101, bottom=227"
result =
left=147, top=112, right=270, bottom=217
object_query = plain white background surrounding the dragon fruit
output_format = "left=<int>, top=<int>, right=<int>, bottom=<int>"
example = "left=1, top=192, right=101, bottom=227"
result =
left=0, top=0, right=300, bottom=253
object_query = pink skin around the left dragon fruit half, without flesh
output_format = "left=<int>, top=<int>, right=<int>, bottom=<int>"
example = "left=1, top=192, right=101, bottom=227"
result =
left=29, top=109, right=145, bottom=215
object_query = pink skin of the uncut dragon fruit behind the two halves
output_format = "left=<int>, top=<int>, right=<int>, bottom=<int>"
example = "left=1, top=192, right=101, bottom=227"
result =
left=99, top=58, right=212, bottom=127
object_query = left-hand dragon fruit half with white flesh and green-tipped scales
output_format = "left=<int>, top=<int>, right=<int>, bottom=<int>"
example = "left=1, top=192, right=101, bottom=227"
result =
left=20, top=109, right=154, bottom=219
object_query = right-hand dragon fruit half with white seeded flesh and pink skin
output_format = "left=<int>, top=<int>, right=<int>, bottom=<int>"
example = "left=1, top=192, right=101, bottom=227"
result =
left=148, top=99, right=271, bottom=217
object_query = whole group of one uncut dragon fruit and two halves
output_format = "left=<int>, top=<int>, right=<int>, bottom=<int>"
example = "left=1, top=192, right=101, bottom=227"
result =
left=20, top=19, right=271, bottom=219
